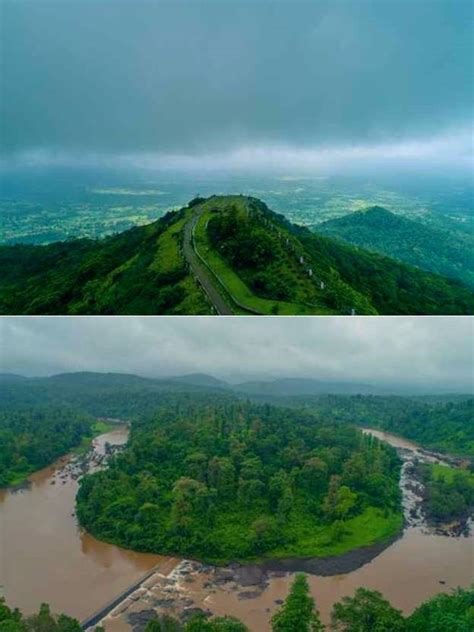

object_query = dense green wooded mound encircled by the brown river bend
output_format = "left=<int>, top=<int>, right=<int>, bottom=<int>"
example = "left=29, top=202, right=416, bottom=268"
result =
left=77, top=395, right=402, bottom=562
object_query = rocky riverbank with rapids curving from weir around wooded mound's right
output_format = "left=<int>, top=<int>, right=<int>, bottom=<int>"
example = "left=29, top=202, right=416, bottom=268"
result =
left=83, top=428, right=472, bottom=632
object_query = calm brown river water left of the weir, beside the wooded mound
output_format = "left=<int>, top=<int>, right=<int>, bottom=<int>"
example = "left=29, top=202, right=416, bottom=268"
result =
left=0, top=428, right=175, bottom=618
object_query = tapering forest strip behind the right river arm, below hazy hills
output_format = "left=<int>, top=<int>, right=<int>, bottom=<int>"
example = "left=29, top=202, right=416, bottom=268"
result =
left=290, top=395, right=474, bottom=457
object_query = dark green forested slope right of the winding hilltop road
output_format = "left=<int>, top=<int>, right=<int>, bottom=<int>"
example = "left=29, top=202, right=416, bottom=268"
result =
left=207, top=197, right=474, bottom=314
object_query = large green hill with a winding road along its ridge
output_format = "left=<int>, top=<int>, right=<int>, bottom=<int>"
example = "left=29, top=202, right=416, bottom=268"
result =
left=0, top=196, right=474, bottom=314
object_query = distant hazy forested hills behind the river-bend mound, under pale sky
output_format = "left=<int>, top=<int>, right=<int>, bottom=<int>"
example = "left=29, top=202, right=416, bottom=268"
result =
left=0, top=373, right=474, bottom=466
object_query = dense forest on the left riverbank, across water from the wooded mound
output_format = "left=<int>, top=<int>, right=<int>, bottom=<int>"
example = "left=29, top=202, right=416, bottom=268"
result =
left=0, top=405, right=94, bottom=487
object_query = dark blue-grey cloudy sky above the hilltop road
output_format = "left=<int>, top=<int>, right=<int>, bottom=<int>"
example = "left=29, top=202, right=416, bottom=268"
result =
left=0, top=0, right=474, bottom=170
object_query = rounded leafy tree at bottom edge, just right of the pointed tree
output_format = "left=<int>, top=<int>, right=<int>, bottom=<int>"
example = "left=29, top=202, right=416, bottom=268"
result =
left=331, top=588, right=407, bottom=632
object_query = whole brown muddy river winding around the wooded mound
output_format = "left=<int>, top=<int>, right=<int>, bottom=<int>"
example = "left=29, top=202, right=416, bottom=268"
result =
left=0, top=429, right=474, bottom=632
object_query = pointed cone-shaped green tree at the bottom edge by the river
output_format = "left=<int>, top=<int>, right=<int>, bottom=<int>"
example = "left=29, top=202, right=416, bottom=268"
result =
left=272, top=573, right=324, bottom=632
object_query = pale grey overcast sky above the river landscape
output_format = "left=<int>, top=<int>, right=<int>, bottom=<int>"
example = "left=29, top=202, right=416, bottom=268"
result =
left=0, top=316, right=474, bottom=391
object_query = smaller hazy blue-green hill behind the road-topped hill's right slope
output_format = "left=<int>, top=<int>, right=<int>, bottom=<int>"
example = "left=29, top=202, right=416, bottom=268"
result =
left=313, top=206, right=474, bottom=287
